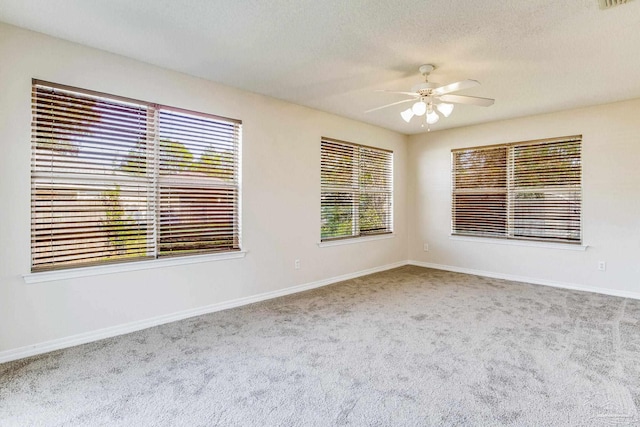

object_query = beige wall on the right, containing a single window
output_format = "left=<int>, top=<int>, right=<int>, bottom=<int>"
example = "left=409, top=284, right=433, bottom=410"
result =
left=407, top=100, right=640, bottom=297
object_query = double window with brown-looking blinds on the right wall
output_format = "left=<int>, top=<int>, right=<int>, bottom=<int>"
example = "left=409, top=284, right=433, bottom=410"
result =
left=451, top=136, right=582, bottom=243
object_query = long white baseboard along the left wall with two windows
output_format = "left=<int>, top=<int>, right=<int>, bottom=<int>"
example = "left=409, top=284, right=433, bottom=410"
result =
left=0, top=261, right=407, bottom=363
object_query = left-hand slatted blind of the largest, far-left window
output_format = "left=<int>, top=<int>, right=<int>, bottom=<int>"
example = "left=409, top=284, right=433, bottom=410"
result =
left=31, top=85, right=155, bottom=271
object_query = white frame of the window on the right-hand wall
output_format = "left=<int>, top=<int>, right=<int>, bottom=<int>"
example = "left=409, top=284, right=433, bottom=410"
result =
left=450, top=135, right=584, bottom=247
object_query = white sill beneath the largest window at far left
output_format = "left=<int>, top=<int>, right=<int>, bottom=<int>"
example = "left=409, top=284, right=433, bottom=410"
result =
left=22, top=251, right=247, bottom=283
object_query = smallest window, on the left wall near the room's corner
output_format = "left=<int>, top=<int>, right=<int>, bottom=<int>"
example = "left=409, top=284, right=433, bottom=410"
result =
left=320, top=138, right=393, bottom=241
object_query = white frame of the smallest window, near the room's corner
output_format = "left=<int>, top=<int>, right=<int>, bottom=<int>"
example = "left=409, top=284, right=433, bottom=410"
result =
left=320, top=137, right=394, bottom=242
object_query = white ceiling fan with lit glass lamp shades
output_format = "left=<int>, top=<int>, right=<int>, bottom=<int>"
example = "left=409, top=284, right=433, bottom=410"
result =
left=365, top=64, right=495, bottom=130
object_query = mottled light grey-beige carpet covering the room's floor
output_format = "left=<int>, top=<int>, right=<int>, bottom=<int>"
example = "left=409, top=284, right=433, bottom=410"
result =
left=0, top=266, right=640, bottom=426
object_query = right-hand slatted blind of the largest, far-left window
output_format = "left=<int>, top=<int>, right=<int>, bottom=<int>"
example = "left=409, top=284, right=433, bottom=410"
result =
left=159, top=109, right=240, bottom=255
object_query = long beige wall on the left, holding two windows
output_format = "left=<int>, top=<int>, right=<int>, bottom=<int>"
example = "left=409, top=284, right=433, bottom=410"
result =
left=0, top=24, right=407, bottom=352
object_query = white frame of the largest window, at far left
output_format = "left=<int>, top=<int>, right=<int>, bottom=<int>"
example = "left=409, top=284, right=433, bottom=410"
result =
left=25, top=79, right=243, bottom=272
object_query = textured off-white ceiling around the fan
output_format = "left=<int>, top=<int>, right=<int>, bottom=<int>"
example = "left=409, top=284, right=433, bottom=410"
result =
left=0, top=0, right=640, bottom=134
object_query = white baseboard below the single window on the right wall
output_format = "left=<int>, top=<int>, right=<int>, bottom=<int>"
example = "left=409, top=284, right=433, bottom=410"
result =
left=407, top=260, right=640, bottom=299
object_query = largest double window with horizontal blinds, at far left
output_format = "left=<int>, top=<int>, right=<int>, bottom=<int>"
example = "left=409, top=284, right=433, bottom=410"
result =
left=31, top=80, right=241, bottom=272
